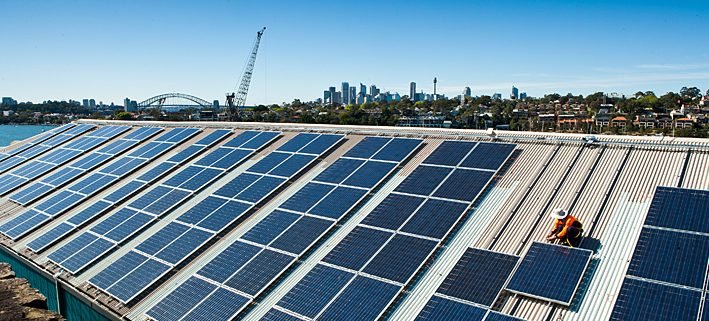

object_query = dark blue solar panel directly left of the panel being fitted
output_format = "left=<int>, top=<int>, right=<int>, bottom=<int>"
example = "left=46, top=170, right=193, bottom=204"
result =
left=436, top=248, right=519, bottom=306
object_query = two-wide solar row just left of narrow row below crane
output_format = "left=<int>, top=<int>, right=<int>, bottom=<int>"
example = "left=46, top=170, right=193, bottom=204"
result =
left=0, top=128, right=200, bottom=240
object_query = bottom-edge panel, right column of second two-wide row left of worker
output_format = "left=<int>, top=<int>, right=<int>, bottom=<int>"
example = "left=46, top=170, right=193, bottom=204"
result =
left=182, top=288, right=249, bottom=321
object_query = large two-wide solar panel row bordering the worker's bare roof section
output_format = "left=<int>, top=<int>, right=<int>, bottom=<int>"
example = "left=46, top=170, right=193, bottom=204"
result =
left=258, top=141, right=515, bottom=320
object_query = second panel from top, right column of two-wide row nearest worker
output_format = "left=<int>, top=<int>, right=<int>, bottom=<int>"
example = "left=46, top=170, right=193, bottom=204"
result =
left=433, top=169, right=494, bottom=202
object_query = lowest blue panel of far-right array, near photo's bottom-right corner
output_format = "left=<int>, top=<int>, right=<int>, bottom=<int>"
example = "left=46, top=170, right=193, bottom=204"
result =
left=610, top=278, right=707, bottom=321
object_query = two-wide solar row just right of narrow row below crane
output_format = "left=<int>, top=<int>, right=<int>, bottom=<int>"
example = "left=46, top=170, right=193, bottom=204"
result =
left=48, top=132, right=278, bottom=274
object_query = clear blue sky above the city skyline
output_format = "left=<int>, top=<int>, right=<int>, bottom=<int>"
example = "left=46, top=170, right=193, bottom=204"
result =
left=0, top=0, right=709, bottom=105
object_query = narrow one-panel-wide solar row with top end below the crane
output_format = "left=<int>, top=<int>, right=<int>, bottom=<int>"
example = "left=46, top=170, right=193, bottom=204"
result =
left=27, top=129, right=231, bottom=253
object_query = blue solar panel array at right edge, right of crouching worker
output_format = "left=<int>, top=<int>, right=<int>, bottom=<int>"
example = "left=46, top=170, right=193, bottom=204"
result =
left=611, top=186, right=709, bottom=321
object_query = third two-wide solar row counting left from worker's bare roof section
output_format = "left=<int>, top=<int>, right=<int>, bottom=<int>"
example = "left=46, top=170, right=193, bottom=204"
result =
left=89, top=134, right=342, bottom=303
